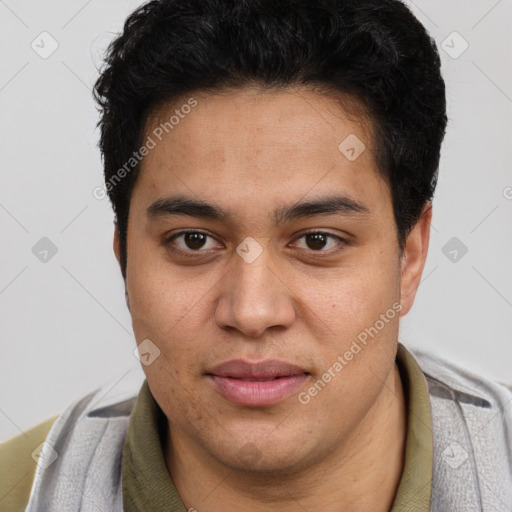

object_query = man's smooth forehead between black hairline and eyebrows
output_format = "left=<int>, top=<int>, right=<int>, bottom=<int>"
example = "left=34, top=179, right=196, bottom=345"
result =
left=134, top=88, right=390, bottom=218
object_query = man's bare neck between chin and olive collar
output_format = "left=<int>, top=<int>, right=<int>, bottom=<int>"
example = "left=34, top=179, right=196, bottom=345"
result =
left=165, top=365, right=407, bottom=512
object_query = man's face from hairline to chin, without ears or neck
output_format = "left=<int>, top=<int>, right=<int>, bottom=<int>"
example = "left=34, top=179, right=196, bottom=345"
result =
left=122, top=89, right=414, bottom=471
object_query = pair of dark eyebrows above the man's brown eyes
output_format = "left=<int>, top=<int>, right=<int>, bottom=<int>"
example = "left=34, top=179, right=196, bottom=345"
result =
left=146, top=195, right=370, bottom=226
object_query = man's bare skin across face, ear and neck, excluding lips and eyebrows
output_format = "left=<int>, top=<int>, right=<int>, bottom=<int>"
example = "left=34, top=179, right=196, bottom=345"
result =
left=114, top=88, right=431, bottom=512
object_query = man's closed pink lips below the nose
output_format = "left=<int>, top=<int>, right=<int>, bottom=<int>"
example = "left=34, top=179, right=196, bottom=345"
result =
left=207, top=359, right=309, bottom=407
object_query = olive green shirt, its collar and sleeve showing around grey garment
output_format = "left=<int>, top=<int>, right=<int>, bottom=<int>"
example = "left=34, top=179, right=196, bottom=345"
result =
left=0, top=344, right=433, bottom=512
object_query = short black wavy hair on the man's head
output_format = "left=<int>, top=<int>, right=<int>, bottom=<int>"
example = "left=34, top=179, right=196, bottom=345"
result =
left=94, top=0, right=447, bottom=277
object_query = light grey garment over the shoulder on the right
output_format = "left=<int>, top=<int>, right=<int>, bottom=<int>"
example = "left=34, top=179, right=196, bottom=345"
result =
left=411, top=344, right=512, bottom=510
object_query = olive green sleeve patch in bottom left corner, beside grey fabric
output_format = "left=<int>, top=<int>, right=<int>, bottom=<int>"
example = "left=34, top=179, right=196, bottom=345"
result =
left=0, top=415, right=58, bottom=512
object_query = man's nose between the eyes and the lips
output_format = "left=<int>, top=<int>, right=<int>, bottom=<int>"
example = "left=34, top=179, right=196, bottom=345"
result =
left=215, top=251, right=296, bottom=338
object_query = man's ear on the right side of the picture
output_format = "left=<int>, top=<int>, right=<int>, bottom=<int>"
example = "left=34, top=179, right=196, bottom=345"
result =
left=400, top=202, right=432, bottom=316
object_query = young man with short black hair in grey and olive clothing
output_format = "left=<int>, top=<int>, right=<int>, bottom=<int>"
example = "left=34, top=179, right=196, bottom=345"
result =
left=2, top=0, right=512, bottom=512
